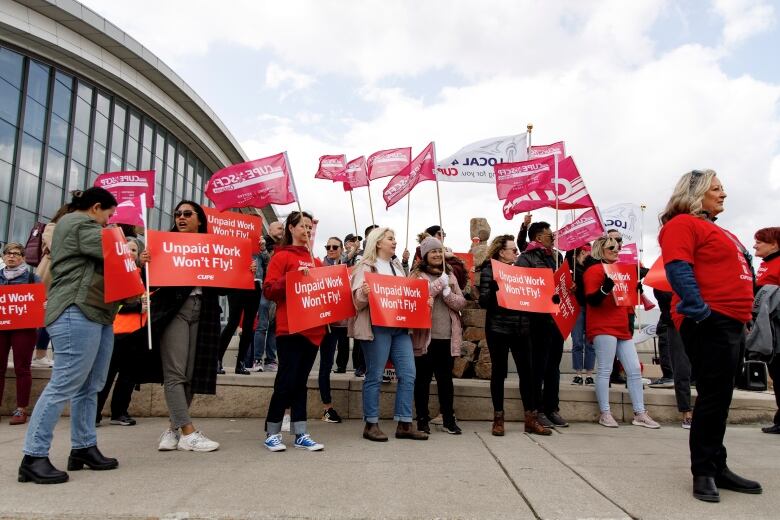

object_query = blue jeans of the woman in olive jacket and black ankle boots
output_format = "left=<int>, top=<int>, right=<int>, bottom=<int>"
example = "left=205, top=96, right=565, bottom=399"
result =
left=22, top=305, right=114, bottom=457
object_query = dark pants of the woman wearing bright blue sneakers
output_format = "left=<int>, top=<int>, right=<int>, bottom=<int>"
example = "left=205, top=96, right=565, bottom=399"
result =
left=265, top=334, right=318, bottom=433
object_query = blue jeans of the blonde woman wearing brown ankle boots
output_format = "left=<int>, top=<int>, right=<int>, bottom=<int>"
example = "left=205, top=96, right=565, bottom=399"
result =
left=361, top=326, right=416, bottom=423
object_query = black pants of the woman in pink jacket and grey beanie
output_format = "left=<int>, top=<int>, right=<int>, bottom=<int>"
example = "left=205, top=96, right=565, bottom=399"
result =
left=414, top=339, right=455, bottom=420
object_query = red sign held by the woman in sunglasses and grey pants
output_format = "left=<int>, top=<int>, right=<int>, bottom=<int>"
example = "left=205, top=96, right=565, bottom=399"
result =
left=146, top=230, right=255, bottom=289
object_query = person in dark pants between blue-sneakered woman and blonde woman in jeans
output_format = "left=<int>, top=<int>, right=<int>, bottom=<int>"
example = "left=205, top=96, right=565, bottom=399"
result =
left=318, top=237, right=349, bottom=423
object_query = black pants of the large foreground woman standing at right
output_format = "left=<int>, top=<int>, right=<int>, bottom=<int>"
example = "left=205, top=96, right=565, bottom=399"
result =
left=680, top=312, right=744, bottom=477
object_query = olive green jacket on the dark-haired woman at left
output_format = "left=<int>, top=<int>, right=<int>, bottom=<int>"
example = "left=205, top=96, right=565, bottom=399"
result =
left=46, top=212, right=119, bottom=325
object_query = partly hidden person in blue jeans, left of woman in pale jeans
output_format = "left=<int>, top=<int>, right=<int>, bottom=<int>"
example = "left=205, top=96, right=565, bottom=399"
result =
left=566, top=245, right=596, bottom=386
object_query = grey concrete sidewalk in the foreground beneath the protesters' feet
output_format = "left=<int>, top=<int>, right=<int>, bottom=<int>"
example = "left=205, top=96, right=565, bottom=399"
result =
left=0, top=418, right=780, bottom=520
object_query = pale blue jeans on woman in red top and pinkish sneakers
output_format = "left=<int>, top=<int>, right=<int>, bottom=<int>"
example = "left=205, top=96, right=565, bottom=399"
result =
left=593, top=335, right=645, bottom=413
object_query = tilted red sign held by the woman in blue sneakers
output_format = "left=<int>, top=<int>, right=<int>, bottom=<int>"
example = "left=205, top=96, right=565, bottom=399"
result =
left=285, top=264, right=355, bottom=334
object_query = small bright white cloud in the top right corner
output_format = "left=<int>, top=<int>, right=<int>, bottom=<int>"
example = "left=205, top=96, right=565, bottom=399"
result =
left=713, top=0, right=775, bottom=47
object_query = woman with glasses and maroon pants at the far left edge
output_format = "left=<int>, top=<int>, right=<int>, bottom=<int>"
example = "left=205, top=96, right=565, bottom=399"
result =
left=0, top=242, right=45, bottom=425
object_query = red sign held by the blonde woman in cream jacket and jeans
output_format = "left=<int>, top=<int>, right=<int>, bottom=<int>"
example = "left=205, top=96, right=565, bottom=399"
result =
left=366, top=273, right=431, bottom=329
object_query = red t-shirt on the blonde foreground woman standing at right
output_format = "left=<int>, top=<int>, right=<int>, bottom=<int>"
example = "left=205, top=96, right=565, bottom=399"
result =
left=658, top=215, right=753, bottom=328
